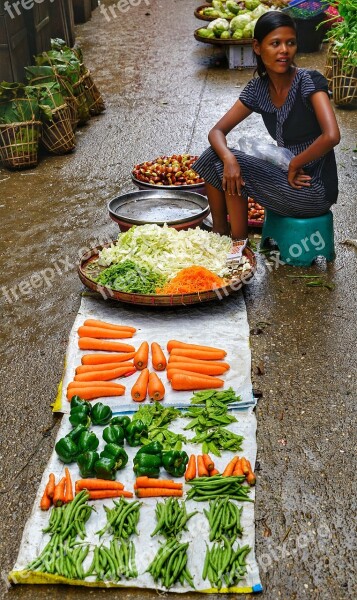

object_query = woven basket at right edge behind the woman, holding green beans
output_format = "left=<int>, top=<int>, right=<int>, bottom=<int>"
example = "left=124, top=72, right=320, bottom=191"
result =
left=332, top=53, right=357, bottom=106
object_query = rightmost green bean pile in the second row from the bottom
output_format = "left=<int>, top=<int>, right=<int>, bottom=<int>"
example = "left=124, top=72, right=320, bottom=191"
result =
left=203, top=497, right=243, bottom=542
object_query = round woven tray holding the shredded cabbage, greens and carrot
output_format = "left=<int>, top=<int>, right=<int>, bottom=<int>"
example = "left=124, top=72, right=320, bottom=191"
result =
left=78, top=244, right=257, bottom=306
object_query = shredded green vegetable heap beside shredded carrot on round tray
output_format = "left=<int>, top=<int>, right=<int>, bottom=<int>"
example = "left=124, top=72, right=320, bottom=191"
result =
left=96, top=260, right=166, bottom=294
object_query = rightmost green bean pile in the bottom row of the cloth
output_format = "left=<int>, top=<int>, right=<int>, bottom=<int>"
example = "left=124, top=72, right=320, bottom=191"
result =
left=202, top=536, right=251, bottom=590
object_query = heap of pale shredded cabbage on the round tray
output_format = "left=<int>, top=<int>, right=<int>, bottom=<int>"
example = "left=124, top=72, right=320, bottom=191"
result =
left=98, top=224, right=232, bottom=279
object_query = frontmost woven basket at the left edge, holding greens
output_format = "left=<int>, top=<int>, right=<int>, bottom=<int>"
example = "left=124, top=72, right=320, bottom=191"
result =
left=0, top=121, right=42, bottom=169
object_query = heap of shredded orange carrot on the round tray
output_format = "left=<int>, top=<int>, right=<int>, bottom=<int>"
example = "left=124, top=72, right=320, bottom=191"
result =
left=156, top=266, right=224, bottom=294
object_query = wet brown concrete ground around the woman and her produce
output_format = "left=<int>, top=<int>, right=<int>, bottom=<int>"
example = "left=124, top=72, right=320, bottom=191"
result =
left=0, top=0, right=357, bottom=600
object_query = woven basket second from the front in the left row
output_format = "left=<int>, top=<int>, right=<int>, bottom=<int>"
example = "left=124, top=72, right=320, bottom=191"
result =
left=41, top=104, right=76, bottom=154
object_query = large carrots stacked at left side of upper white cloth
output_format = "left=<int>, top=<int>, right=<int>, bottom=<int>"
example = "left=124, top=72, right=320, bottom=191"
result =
left=67, top=319, right=136, bottom=400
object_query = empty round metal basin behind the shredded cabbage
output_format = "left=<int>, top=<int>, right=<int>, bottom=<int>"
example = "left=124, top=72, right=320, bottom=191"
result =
left=108, top=189, right=209, bottom=231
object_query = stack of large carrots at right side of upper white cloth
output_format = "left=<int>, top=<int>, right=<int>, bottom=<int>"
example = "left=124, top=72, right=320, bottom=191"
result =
left=167, top=340, right=229, bottom=390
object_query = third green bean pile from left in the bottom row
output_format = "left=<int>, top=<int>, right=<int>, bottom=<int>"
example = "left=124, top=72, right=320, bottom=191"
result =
left=147, top=538, right=195, bottom=589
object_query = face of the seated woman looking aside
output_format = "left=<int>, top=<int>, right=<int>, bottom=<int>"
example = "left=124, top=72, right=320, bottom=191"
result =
left=253, top=27, right=297, bottom=73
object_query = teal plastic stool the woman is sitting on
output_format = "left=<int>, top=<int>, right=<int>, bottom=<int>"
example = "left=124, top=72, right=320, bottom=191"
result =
left=261, top=209, right=336, bottom=267
